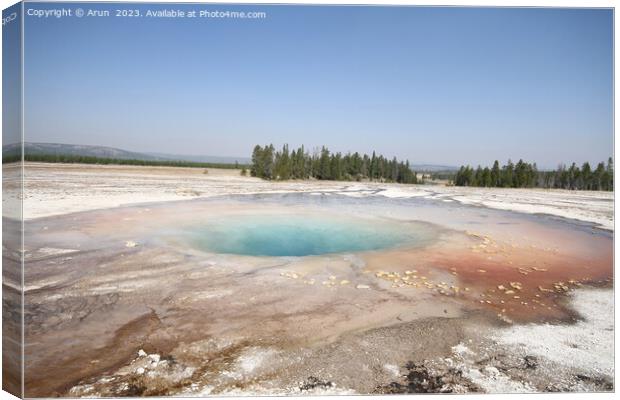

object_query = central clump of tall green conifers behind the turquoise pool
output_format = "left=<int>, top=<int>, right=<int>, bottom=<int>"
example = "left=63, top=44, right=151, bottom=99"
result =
left=250, top=144, right=418, bottom=183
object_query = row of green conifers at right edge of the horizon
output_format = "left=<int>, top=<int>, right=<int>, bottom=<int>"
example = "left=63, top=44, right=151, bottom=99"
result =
left=453, top=157, right=614, bottom=191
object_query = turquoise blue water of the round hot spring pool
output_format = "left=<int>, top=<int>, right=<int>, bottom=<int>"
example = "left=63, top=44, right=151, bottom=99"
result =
left=186, top=215, right=434, bottom=257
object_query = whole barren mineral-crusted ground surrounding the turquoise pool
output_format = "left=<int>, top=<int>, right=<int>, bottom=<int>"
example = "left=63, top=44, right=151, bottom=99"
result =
left=4, top=164, right=614, bottom=397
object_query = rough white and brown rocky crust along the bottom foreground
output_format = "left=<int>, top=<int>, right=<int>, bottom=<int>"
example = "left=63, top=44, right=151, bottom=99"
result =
left=65, top=290, right=613, bottom=396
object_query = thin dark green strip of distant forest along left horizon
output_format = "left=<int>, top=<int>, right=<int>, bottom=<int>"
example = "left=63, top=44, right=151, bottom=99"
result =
left=2, top=153, right=250, bottom=169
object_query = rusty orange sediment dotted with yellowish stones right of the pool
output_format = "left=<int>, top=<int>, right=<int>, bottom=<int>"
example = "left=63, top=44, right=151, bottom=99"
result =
left=360, top=228, right=613, bottom=322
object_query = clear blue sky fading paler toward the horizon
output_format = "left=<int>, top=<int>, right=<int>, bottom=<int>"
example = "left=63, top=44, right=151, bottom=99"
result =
left=25, top=3, right=613, bottom=167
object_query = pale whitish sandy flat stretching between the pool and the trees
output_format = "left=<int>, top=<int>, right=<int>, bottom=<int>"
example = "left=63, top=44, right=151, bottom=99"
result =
left=12, top=163, right=614, bottom=230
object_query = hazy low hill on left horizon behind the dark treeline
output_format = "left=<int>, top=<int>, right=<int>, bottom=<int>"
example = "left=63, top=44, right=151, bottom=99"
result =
left=2, top=142, right=250, bottom=164
